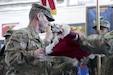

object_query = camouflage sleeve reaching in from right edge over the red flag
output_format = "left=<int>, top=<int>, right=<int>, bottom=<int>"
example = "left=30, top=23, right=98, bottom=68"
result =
left=79, top=31, right=113, bottom=55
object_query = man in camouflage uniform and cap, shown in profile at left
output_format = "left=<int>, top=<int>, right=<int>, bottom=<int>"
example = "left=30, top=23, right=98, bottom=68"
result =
left=5, top=4, right=54, bottom=75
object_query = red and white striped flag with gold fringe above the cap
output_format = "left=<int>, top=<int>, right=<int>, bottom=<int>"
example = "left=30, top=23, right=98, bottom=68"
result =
left=40, top=0, right=56, bottom=15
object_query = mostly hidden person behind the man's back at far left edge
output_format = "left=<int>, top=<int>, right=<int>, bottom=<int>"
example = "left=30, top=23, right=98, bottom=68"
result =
left=0, top=30, right=13, bottom=75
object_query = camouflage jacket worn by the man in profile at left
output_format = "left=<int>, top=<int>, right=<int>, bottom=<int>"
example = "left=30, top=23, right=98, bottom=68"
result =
left=5, top=26, right=51, bottom=75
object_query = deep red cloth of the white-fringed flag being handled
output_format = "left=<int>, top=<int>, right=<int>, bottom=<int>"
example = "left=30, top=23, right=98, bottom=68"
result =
left=49, top=37, right=90, bottom=60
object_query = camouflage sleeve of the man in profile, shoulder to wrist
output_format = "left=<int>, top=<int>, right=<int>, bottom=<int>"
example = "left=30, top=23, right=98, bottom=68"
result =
left=5, top=32, right=33, bottom=66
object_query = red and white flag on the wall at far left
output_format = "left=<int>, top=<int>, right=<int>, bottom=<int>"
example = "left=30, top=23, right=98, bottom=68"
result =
left=2, top=23, right=19, bottom=36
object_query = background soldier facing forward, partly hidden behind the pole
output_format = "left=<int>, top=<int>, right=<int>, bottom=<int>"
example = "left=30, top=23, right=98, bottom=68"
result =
left=88, top=17, right=110, bottom=75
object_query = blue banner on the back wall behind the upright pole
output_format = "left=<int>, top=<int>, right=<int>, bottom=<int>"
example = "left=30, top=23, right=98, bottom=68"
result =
left=87, top=7, right=113, bottom=35
